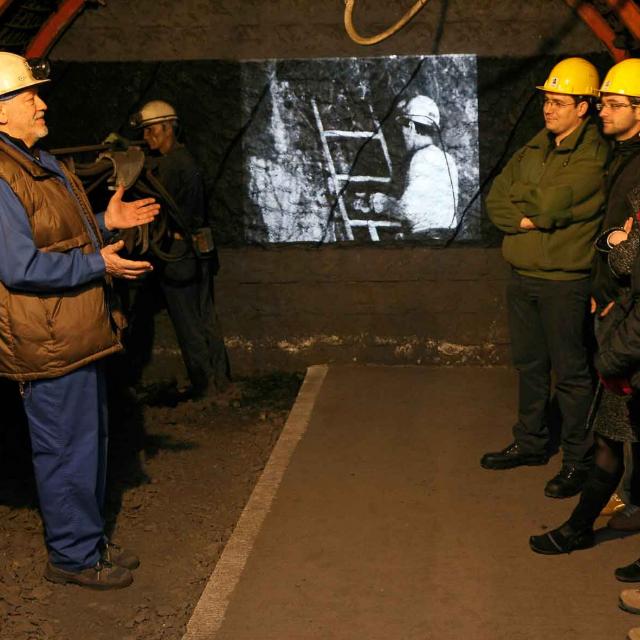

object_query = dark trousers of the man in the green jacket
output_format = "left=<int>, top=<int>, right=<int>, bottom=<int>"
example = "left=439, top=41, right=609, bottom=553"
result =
left=507, top=272, right=593, bottom=468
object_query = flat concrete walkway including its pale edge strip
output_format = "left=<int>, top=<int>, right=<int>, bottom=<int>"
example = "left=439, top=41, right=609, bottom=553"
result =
left=185, top=366, right=640, bottom=640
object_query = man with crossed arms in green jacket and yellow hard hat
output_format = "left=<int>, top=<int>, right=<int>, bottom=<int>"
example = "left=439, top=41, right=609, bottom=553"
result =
left=481, top=58, right=609, bottom=498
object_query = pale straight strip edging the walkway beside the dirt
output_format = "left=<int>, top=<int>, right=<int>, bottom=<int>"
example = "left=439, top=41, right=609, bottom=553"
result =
left=182, top=365, right=329, bottom=640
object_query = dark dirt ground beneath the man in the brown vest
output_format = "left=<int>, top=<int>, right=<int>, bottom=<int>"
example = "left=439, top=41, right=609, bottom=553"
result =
left=0, top=374, right=302, bottom=640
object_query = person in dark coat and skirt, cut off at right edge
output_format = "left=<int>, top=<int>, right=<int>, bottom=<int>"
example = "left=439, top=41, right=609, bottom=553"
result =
left=529, top=211, right=640, bottom=581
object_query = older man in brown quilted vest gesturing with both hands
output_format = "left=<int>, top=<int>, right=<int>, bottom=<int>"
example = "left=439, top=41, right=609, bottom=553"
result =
left=0, top=52, right=159, bottom=589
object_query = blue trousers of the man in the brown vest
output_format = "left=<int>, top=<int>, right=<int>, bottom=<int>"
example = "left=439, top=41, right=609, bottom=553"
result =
left=23, top=363, right=108, bottom=571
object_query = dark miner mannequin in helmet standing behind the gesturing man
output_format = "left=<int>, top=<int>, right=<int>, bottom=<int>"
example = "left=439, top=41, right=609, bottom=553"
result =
left=130, top=100, right=229, bottom=399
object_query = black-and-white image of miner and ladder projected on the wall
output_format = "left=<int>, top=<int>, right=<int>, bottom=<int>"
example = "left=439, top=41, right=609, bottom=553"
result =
left=242, top=55, right=479, bottom=243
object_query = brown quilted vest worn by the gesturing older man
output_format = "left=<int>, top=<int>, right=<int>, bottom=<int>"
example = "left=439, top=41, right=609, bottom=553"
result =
left=0, top=140, right=122, bottom=381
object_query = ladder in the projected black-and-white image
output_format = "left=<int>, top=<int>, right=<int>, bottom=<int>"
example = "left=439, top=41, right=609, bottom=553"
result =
left=311, top=98, right=401, bottom=241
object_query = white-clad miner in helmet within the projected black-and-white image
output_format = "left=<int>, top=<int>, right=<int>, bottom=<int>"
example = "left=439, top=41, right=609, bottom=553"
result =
left=372, top=96, right=458, bottom=237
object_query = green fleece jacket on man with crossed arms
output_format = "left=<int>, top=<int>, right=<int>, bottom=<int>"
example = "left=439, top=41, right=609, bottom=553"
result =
left=486, top=120, right=610, bottom=280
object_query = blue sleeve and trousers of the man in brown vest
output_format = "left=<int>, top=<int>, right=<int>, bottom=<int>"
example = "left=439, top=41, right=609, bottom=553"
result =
left=0, top=136, right=107, bottom=571
